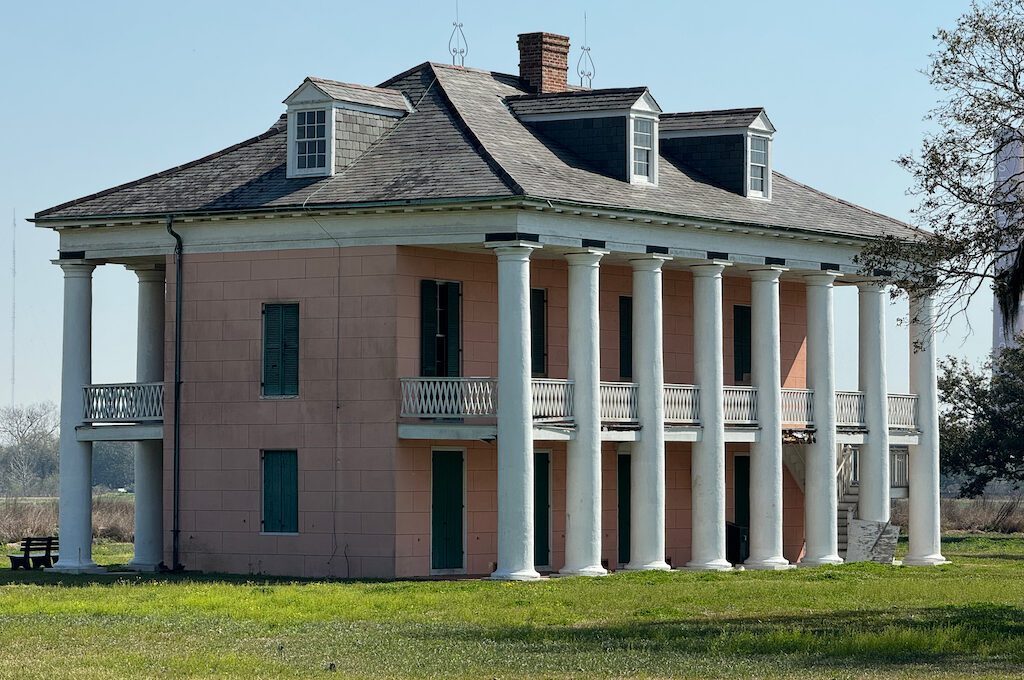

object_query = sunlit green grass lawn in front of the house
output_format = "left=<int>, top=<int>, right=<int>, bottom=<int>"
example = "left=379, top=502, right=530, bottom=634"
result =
left=0, top=535, right=1024, bottom=679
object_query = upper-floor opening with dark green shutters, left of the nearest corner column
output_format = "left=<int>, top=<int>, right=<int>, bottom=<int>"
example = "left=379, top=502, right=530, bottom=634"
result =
left=420, top=280, right=462, bottom=378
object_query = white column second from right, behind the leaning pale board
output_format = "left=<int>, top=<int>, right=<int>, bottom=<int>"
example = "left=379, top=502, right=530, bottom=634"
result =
left=857, top=282, right=889, bottom=522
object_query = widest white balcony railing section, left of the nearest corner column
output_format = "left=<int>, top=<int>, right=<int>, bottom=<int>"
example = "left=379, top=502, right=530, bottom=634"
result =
left=401, top=378, right=498, bottom=418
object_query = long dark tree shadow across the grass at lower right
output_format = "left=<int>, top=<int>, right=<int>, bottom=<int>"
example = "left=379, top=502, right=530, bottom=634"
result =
left=385, top=604, right=1024, bottom=673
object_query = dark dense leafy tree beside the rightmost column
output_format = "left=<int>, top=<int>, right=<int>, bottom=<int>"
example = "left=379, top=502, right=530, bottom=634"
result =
left=939, top=347, right=1024, bottom=498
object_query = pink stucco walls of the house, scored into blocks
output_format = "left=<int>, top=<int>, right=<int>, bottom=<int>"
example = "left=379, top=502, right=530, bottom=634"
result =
left=165, top=247, right=806, bottom=577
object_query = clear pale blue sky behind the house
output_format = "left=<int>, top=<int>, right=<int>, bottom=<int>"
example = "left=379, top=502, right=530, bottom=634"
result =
left=0, top=0, right=991, bottom=406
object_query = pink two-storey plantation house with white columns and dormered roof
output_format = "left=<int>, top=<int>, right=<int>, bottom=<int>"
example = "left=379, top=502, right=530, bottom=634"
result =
left=36, top=33, right=943, bottom=580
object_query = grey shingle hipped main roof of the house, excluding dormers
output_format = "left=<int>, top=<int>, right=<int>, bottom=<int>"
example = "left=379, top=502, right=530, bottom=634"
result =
left=36, top=63, right=916, bottom=238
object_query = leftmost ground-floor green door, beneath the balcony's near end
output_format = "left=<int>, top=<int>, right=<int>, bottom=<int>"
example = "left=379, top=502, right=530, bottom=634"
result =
left=430, top=451, right=464, bottom=569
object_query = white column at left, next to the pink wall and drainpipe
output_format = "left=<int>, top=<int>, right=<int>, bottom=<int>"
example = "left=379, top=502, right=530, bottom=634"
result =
left=128, top=265, right=165, bottom=571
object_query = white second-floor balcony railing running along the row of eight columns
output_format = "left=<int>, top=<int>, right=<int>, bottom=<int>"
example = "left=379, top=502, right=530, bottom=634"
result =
left=400, top=378, right=918, bottom=431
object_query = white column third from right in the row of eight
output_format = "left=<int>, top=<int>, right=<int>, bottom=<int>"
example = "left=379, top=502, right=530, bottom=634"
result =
left=800, top=271, right=843, bottom=566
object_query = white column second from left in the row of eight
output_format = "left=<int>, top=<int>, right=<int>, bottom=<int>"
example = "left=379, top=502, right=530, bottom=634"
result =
left=559, top=249, right=607, bottom=576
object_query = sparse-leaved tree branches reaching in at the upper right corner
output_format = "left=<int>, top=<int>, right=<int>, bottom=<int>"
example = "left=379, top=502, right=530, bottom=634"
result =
left=859, top=0, right=1024, bottom=326
